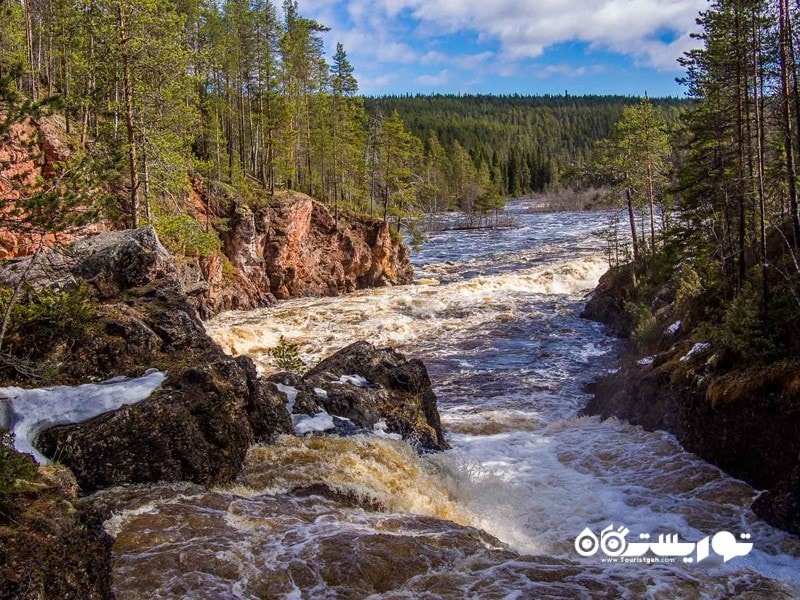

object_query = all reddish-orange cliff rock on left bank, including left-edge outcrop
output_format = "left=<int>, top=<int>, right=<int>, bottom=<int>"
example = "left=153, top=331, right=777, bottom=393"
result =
left=0, top=117, right=412, bottom=318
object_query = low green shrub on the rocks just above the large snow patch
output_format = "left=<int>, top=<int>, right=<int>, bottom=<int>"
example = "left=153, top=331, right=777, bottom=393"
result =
left=0, top=287, right=97, bottom=354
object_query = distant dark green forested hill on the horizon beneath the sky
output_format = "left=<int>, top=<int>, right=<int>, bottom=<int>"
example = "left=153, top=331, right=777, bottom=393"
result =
left=366, top=94, right=686, bottom=197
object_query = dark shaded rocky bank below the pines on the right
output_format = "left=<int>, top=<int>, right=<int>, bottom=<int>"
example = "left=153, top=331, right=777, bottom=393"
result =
left=584, top=268, right=800, bottom=534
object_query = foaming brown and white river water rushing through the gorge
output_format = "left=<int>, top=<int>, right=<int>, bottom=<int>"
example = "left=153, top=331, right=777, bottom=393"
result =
left=103, top=203, right=800, bottom=599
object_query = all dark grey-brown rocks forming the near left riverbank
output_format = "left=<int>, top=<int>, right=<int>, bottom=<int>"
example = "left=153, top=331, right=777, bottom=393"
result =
left=0, top=227, right=438, bottom=598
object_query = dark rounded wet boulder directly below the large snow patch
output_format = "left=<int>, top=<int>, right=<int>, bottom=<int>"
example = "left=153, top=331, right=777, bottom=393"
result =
left=37, top=361, right=255, bottom=491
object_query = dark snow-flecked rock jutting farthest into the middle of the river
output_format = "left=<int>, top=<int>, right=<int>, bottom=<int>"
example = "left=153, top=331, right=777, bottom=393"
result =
left=303, top=342, right=448, bottom=450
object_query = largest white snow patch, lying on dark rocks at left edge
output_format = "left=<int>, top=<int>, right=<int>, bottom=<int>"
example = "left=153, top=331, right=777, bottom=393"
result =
left=0, top=369, right=167, bottom=465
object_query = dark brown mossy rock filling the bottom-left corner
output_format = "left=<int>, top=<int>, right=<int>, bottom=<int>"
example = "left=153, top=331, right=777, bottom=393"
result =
left=0, top=466, right=114, bottom=600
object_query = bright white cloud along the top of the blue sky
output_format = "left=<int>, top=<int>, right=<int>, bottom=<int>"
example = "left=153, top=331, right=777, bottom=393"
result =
left=322, top=0, right=706, bottom=70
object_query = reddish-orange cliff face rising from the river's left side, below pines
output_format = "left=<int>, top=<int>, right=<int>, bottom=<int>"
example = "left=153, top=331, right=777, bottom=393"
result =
left=191, top=182, right=412, bottom=314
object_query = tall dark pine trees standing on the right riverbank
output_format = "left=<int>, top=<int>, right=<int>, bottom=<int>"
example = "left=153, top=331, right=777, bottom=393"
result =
left=597, top=0, right=800, bottom=365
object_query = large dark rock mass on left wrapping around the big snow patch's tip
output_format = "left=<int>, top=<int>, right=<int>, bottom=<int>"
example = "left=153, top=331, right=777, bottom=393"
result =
left=3, top=228, right=292, bottom=490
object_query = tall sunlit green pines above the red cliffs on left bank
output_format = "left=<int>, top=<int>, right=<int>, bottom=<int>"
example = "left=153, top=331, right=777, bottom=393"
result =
left=0, top=0, right=434, bottom=232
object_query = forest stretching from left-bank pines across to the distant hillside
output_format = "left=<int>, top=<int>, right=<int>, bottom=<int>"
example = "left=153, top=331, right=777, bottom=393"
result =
left=0, top=0, right=685, bottom=240
